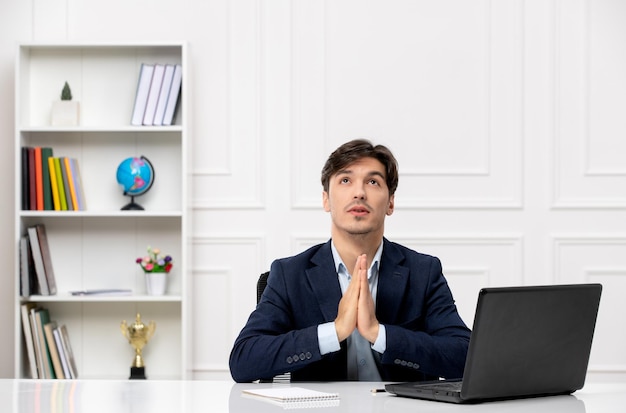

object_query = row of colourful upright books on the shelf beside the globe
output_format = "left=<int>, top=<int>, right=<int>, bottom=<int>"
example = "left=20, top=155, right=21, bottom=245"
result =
left=21, top=146, right=86, bottom=211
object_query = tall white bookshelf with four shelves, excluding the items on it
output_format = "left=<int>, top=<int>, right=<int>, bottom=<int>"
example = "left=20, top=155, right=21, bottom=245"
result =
left=14, top=42, right=190, bottom=379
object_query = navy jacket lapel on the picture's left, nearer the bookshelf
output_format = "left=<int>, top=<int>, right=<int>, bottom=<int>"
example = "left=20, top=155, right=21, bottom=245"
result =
left=306, top=241, right=341, bottom=321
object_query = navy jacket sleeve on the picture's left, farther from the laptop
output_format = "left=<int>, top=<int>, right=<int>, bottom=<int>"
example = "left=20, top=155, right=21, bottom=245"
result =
left=229, top=262, right=322, bottom=382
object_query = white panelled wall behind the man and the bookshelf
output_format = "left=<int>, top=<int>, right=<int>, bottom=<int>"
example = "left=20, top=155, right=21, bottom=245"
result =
left=0, top=0, right=626, bottom=379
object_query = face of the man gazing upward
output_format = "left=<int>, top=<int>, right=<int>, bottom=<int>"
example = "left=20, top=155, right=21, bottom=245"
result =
left=322, top=157, right=394, bottom=236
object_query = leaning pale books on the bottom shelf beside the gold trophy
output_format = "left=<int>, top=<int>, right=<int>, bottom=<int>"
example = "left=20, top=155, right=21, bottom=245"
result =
left=21, top=303, right=78, bottom=379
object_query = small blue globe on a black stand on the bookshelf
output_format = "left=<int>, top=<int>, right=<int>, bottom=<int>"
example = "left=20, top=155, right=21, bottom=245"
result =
left=117, top=156, right=154, bottom=210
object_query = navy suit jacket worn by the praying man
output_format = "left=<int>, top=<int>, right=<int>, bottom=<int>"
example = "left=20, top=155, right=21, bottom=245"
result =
left=229, top=239, right=470, bottom=382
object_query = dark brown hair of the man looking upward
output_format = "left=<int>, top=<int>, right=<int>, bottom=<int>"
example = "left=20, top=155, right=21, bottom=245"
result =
left=322, top=139, right=398, bottom=196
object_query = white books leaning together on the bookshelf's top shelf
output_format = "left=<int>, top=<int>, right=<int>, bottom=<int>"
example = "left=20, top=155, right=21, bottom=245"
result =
left=131, top=63, right=183, bottom=126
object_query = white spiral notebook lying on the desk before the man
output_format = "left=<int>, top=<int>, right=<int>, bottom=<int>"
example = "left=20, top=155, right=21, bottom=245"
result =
left=241, top=386, right=339, bottom=408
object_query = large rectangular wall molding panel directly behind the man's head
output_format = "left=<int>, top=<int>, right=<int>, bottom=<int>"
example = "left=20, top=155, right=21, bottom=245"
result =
left=292, top=1, right=523, bottom=209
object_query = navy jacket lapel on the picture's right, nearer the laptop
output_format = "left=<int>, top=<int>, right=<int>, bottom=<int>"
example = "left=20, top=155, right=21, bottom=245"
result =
left=376, top=239, right=409, bottom=324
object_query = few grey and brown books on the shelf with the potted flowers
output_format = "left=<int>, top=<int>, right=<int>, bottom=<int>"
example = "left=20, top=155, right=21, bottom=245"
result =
left=20, top=224, right=57, bottom=297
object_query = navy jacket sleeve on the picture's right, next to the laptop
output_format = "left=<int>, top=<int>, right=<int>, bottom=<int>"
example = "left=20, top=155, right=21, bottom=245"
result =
left=381, top=257, right=470, bottom=378
